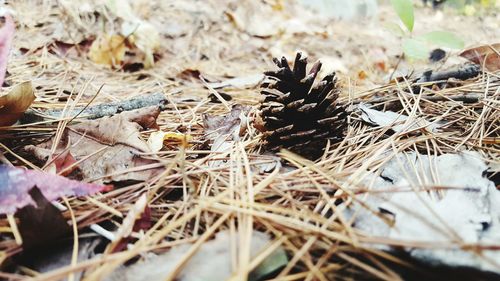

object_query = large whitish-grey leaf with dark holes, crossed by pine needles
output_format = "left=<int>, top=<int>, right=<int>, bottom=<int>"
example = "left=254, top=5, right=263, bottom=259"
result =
left=341, top=151, right=500, bottom=274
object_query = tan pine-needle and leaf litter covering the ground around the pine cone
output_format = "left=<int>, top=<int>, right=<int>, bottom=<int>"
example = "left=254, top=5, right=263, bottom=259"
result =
left=0, top=1, right=500, bottom=280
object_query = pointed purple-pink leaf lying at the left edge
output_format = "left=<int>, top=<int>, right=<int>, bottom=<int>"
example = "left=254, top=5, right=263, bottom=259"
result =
left=0, top=165, right=109, bottom=214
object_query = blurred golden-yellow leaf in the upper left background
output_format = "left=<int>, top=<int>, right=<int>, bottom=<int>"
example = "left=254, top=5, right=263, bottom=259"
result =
left=89, top=34, right=127, bottom=67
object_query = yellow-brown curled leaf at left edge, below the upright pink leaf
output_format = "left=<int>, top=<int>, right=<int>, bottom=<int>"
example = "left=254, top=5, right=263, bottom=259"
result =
left=0, top=81, right=35, bottom=126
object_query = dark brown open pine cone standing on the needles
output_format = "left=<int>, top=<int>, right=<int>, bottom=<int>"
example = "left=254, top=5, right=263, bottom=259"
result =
left=258, top=53, right=347, bottom=159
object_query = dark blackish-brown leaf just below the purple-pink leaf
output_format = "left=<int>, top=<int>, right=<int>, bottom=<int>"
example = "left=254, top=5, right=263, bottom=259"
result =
left=16, top=187, right=71, bottom=250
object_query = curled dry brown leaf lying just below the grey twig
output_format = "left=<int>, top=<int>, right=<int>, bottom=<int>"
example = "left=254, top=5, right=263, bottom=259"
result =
left=25, top=107, right=160, bottom=182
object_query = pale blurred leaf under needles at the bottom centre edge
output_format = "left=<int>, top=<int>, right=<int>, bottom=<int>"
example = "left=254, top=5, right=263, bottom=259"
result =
left=104, top=230, right=288, bottom=281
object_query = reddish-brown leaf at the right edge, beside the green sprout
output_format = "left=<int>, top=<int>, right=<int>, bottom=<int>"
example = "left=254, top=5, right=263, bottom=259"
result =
left=460, top=43, right=500, bottom=71
